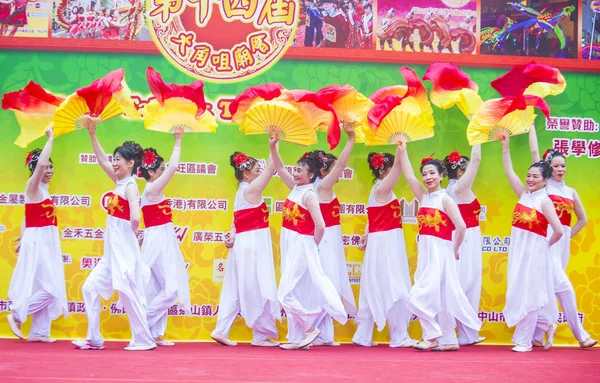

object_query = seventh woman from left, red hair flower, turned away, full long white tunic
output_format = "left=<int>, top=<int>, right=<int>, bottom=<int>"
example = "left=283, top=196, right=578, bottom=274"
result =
left=352, top=149, right=416, bottom=347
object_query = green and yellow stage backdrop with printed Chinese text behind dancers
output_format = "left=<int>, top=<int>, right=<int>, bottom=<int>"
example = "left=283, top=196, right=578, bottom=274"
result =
left=0, top=51, right=600, bottom=344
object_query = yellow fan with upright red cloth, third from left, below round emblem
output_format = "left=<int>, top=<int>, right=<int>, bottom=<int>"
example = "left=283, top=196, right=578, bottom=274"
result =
left=143, top=67, right=217, bottom=133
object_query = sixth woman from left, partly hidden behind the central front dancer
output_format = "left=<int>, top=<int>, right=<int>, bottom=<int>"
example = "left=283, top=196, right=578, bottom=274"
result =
left=312, top=124, right=356, bottom=346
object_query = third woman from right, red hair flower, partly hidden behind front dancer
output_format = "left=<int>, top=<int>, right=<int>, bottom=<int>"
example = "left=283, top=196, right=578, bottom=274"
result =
left=444, top=145, right=485, bottom=346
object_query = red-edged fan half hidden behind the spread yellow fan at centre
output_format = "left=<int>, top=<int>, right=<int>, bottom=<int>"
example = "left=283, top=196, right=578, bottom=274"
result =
left=278, top=90, right=342, bottom=150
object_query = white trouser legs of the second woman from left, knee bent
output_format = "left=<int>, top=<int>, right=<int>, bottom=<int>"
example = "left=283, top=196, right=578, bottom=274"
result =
left=83, top=262, right=154, bottom=346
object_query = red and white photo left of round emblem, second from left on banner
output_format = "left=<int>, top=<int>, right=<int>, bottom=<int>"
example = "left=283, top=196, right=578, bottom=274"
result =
left=52, top=0, right=152, bottom=40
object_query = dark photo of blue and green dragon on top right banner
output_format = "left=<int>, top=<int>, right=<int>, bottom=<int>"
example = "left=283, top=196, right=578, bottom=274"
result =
left=480, top=0, right=578, bottom=58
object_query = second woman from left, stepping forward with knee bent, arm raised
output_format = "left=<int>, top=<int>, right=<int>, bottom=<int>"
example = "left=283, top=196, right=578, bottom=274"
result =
left=73, top=125, right=156, bottom=351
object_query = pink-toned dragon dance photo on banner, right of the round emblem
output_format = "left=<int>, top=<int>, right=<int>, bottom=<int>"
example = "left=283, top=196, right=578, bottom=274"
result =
left=375, top=0, right=477, bottom=54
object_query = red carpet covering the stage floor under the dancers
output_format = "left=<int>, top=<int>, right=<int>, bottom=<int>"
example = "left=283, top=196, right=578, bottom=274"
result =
left=0, top=339, right=600, bottom=383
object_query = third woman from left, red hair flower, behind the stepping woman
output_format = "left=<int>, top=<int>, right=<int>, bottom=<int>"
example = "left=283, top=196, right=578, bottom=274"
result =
left=141, top=128, right=190, bottom=346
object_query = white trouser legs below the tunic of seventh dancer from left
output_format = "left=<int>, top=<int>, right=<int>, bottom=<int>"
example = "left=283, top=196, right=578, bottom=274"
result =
left=352, top=300, right=412, bottom=347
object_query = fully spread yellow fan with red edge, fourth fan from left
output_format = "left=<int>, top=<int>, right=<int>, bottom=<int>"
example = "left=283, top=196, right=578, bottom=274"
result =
left=229, top=84, right=317, bottom=146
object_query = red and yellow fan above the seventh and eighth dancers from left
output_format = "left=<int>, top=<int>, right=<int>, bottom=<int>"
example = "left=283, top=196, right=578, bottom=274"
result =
left=365, top=67, right=435, bottom=146
